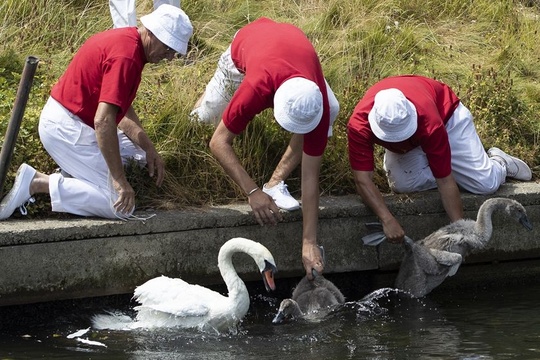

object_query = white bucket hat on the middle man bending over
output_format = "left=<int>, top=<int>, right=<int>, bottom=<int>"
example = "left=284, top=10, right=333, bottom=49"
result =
left=274, top=77, right=323, bottom=134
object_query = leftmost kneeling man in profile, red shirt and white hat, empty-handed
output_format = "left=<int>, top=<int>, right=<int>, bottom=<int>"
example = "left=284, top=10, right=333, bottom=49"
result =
left=0, top=5, right=193, bottom=220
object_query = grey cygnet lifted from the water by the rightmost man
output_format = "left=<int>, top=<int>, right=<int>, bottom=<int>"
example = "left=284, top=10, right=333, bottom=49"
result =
left=395, top=198, right=532, bottom=297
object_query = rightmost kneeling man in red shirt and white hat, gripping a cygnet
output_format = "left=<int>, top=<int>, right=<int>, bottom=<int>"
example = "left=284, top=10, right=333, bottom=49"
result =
left=348, top=75, right=532, bottom=242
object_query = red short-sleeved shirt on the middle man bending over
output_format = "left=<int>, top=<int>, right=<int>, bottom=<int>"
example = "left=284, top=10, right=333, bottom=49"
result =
left=223, top=18, right=330, bottom=156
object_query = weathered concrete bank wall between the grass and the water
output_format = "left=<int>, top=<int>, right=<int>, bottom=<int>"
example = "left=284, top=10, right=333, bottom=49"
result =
left=0, top=183, right=540, bottom=305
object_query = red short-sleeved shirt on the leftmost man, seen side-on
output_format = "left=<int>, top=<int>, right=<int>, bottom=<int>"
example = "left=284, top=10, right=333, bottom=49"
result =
left=51, top=27, right=147, bottom=127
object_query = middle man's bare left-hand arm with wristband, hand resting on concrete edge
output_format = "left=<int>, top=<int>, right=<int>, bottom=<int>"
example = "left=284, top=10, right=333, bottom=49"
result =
left=210, top=121, right=282, bottom=225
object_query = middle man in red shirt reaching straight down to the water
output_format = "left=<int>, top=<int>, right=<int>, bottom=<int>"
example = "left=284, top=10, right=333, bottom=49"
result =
left=192, top=18, right=339, bottom=277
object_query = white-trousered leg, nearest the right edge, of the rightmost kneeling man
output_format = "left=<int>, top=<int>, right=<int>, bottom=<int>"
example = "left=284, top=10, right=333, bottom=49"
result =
left=446, top=104, right=506, bottom=194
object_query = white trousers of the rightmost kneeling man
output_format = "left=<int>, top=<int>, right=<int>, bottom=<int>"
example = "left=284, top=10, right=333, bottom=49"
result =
left=384, top=103, right=506, bottom=195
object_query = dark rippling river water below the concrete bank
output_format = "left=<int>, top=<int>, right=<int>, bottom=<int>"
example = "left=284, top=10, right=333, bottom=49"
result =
left=0, top=272, right=540, bottom=360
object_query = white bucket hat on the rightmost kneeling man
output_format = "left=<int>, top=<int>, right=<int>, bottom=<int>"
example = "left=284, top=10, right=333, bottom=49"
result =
left=368, top=88, right=418, bottom=142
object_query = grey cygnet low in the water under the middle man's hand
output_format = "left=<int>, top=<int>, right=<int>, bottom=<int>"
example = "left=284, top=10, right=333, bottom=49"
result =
left=272, top=275, right=345, bottom=324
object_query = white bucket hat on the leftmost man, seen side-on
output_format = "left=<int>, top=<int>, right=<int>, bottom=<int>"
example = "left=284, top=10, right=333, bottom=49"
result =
left=141, top=4, right=193, bottom=55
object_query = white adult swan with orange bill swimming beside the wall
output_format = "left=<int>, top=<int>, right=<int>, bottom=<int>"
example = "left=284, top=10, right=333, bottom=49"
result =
left=92, top=238, right=277, bottom=332
